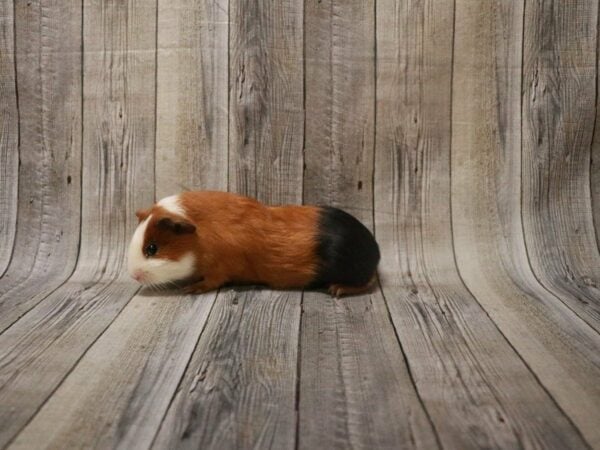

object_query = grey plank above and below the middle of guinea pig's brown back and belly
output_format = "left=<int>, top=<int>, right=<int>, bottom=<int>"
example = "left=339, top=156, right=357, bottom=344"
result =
left=153, top=0, right=303, bottom=449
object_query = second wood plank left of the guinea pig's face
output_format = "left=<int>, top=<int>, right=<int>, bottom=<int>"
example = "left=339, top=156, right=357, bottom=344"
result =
left=0, top=0, right=82, bottom=332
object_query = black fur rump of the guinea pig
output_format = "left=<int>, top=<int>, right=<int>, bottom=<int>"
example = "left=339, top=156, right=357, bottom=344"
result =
left=313, top=206, right=380, bottom=287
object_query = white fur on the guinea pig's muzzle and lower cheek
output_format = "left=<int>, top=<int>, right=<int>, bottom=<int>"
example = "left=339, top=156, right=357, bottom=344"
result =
left=127, top=214, right=196, bottom=284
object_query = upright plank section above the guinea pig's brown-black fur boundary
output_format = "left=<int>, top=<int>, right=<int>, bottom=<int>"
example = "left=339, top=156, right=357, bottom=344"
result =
left=304, top=0, right=375, bottom=216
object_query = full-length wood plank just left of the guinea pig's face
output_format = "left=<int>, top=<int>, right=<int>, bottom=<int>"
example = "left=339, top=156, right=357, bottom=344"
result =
left=0, top=1, right=156, bottom=445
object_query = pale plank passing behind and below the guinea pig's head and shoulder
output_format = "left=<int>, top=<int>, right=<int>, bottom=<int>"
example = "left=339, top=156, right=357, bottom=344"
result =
left=15, top=2, right=228, bottom=449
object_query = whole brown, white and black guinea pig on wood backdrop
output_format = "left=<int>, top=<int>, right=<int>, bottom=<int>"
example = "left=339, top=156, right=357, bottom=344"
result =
left=127, top=191, right=380, bottom=297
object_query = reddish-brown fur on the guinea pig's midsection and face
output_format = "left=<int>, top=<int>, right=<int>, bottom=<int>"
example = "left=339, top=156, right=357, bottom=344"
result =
left=136, top=192, right=319, bottom=292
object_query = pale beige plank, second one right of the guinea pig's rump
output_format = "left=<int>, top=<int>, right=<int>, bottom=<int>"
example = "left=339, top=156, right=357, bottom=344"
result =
left=452, top=0, right=600, bottom=445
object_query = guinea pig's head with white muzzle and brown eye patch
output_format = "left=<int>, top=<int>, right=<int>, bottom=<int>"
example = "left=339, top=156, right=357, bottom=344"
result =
left=127, top=206, right=197, bottom=286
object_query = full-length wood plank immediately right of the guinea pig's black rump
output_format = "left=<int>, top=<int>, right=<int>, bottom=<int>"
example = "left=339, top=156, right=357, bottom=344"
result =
left=375, top=1, right=585, bottom=449
